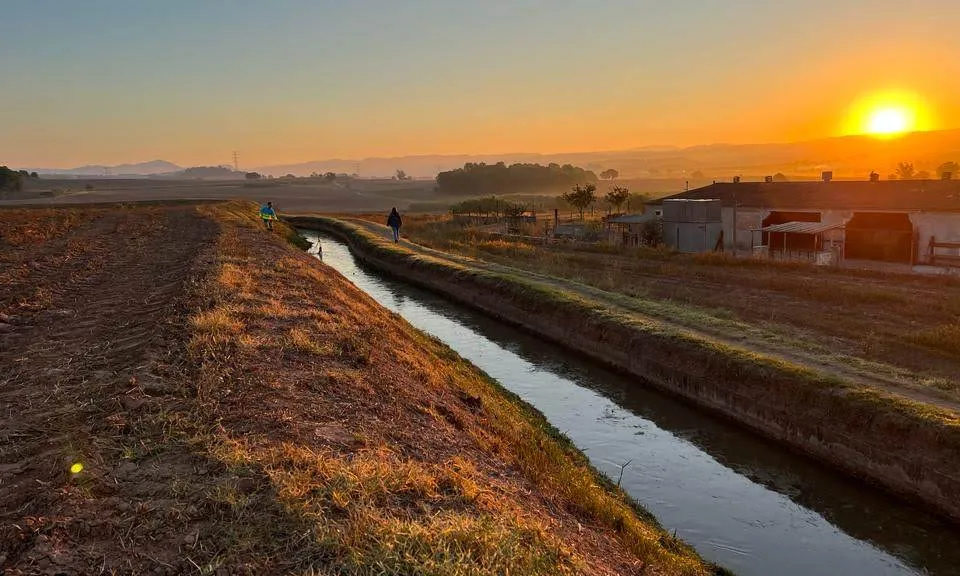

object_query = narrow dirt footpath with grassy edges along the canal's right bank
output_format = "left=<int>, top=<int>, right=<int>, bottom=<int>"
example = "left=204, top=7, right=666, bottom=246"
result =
left=349, top=219, right=960, bottom=412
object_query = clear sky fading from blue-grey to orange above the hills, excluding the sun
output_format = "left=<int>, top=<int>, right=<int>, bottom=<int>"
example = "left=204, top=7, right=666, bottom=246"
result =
left=0, top=0, right=960, bottom=168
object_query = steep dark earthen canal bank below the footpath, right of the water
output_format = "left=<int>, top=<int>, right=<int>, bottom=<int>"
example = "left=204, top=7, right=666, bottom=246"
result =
left=291, top=217, right=960, bottom=519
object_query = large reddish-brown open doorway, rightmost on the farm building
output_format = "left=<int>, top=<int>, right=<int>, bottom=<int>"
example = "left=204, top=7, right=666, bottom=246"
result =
left=845, top=212, right=914, bottom=264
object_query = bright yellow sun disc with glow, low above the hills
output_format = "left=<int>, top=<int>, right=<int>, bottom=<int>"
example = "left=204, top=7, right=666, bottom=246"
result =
left=844, top=92, right=934, bottom=138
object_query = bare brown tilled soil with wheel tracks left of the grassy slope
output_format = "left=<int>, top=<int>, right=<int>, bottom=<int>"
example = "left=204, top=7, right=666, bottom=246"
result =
left=0, top=208, right=217, bottom=574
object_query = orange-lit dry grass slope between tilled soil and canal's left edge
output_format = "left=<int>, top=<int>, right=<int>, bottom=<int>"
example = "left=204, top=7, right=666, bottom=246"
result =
left=176, top=205, right=709, bottom=574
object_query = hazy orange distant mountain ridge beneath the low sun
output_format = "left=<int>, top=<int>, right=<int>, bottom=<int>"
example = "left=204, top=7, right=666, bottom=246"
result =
left=257, top=130, right=960, bottom=180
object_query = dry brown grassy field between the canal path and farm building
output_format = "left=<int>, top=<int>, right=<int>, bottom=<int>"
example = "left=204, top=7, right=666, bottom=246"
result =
left=378, top=216, right=960, bottom=402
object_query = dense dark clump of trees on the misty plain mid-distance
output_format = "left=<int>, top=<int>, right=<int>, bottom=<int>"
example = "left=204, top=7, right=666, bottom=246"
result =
left=437, top=162, right=597, bottom=196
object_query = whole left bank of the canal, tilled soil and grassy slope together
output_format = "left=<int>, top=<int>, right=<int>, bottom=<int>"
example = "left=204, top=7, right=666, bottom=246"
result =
left=0, top=203, right=717, bottom=575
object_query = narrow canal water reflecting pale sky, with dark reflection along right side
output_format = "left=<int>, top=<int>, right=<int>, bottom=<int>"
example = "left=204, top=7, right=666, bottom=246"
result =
left=304, top=232, right=960, bottom=576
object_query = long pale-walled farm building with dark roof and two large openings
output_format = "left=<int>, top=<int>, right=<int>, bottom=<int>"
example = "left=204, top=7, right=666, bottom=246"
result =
left=651, top=179, right=960, bottom=265
